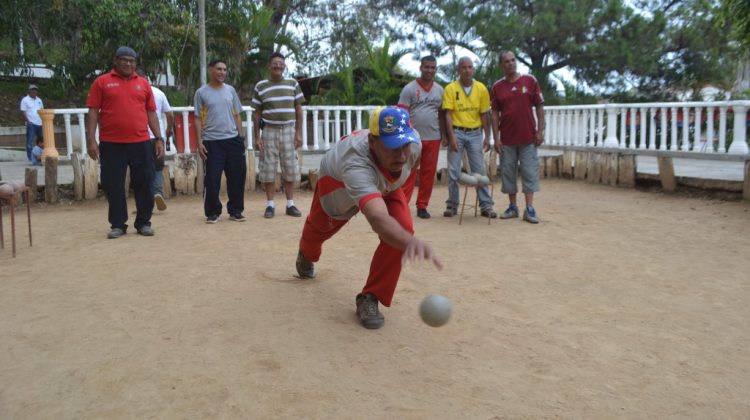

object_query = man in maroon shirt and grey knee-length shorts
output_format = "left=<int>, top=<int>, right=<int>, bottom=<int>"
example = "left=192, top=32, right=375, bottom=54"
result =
left=490, top=51, right=544, bottom=223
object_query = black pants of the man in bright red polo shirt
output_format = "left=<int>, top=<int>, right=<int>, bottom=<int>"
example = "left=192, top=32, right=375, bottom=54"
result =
left=99, top=140, right=154, bottom=230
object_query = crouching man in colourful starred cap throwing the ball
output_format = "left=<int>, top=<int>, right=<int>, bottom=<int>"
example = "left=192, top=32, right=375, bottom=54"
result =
left=297, top=107, right=442, bottom=329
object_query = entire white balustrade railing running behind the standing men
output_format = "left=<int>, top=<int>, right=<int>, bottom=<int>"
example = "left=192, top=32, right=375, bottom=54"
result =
left=48, top=101, right=750, bottom=157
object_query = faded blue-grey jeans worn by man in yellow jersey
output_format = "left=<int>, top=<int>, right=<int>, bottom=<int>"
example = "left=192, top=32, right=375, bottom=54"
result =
left=445, top=129, right=494, bottom=210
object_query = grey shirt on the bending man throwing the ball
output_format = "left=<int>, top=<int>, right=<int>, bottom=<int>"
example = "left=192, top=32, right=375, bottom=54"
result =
left=318, top=130, right=422, bottom=220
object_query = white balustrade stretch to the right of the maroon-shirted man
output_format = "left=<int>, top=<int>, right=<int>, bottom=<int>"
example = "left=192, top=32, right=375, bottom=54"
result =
left=544, top=101, right=750, bottom=154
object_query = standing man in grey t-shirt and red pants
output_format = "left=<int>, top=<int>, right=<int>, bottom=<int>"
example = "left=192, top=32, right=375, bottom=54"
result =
left=398, top=55, right=445, bottom=219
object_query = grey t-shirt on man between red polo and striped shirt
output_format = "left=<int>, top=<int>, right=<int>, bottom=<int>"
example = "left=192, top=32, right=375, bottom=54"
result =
left=195, top=84, right=242, bottom=141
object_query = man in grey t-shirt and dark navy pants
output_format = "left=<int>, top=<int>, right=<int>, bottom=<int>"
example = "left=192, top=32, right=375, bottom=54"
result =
left=195, top=60, right=247, bottom=223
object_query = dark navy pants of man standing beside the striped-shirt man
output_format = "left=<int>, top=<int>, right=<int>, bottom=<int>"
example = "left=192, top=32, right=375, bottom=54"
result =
left=203, top=137, right=247, bottom=217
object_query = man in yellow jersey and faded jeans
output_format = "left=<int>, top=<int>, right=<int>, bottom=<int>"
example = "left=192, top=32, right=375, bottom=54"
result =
left=443, top=57, right=497, bottom=219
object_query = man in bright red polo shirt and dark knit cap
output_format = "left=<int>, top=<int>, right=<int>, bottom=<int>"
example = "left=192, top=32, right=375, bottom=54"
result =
left=86, top=47, right=164, bottom=239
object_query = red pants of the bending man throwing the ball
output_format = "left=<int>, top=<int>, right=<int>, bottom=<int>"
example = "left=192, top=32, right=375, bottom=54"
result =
left=299, top=178, right=414, bottom=306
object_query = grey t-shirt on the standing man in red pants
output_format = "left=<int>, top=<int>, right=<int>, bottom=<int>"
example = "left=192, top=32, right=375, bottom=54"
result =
left=398, top=80, right=443, bottom=140
